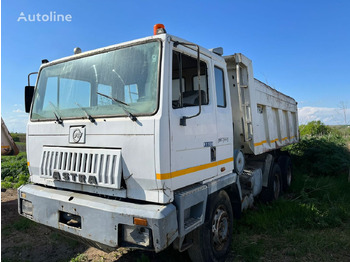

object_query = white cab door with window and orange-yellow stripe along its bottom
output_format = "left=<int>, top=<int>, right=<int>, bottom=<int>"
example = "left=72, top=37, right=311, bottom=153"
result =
left=169, top=45, right=218, bottom=189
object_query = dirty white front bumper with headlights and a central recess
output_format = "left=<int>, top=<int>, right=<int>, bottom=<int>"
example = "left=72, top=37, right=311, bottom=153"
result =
left=18, top=185, right=178, bottom=252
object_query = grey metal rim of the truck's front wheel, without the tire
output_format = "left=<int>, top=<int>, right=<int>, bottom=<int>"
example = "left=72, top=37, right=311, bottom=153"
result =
left=212, top=205, right=230, bottom=251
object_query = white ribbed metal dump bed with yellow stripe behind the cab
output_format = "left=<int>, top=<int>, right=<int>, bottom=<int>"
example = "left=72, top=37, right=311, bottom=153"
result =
left=225, top=54, right=299, bottom=155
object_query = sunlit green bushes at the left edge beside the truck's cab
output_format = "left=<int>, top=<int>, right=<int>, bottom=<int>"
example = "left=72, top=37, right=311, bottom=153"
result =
left=1, top=152, right=29, bottom=188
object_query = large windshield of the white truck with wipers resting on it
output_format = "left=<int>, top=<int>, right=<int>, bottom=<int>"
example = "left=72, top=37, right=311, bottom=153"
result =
left=31, top=42, right=160, bottom=120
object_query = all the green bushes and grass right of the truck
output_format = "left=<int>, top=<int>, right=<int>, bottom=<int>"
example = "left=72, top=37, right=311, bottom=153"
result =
left=233, top=121, right=350, bottom=261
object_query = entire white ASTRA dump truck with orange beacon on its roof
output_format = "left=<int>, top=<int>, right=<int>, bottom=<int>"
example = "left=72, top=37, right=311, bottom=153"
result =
left=18, top=24, right=299, bottom=261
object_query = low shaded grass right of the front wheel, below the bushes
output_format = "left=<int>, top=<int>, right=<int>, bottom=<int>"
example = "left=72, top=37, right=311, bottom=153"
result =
left=233, top=170, right=350, bottom=261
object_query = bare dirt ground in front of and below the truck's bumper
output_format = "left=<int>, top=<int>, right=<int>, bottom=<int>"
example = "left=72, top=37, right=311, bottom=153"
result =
left=1, top=189, right=197, bottom=262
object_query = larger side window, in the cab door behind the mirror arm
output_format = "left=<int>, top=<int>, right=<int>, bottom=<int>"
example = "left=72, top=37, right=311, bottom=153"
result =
left=172, top=51, right=209, bottom=108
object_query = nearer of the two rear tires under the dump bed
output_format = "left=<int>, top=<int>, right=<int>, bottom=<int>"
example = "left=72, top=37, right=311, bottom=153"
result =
left=260, top=163, right=282, bottom=202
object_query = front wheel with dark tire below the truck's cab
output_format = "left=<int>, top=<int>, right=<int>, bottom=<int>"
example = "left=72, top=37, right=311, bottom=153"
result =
left=188, top=190, right=233, bottom=262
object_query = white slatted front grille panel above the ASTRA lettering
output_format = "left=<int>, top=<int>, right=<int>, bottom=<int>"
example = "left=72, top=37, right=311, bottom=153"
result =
left=40, top=147, right=121, bottom=189
